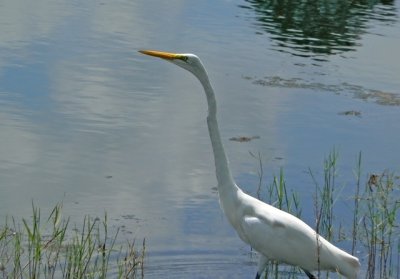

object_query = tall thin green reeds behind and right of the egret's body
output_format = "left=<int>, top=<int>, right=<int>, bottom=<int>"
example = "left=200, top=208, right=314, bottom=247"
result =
left=253, top=150, right=400, bottom=279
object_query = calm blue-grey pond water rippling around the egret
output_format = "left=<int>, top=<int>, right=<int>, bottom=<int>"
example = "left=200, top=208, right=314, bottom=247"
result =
left=0, top=0, right=400, bottom=278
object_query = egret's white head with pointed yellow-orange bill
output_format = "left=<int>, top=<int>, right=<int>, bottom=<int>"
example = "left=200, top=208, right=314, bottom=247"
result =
left=139, top=50, right=205, bottom=78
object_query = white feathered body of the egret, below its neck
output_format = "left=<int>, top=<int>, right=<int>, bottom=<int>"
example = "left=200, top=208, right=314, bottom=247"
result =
left=221, top=188, right=359, bottom=278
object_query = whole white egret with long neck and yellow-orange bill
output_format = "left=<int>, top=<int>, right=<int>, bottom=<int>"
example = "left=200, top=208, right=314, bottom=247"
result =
left=140, top=50, right=360, bottom=279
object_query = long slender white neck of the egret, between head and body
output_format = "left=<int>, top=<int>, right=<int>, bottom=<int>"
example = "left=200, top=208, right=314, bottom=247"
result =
left=195, top=70, right=236, bottom=192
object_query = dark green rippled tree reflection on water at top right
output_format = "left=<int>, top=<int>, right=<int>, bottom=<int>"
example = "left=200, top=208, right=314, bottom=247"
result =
left=241, top=0, right=397, bottom=60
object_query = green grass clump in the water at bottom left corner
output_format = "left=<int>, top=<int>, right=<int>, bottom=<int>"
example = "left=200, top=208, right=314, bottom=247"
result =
left=0, top=204, right=145, bottom=278
